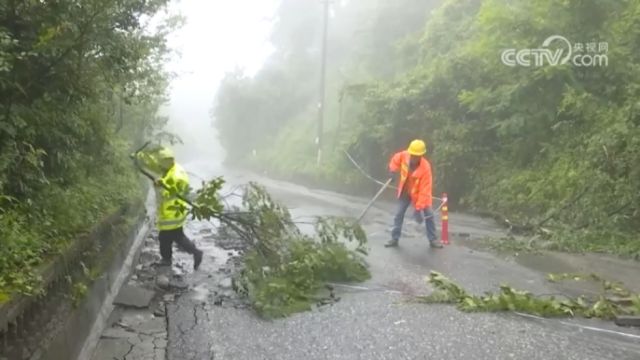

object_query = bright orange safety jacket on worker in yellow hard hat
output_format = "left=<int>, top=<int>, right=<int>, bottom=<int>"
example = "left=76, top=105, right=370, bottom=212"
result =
left=389, top=150, right=433, bottom=210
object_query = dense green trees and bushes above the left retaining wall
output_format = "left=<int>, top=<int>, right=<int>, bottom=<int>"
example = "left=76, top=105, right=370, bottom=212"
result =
left=0, top=0, right=174, bottom=303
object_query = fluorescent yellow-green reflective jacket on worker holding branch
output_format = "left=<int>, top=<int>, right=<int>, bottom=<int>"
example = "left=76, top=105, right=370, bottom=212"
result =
left=158, top=164, right=189, bottom=230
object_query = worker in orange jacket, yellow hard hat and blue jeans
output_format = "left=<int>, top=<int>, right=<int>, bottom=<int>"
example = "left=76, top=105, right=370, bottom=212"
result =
left=385, top=140, right=442, bottom=248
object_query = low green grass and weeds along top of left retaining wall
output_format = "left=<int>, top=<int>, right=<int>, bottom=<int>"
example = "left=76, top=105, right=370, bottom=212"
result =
left=0, top=170, right=143, bottom=303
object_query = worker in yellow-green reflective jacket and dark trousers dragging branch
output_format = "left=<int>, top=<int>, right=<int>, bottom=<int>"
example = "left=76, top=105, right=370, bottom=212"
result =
left=141, top=148, right=203, bottom=270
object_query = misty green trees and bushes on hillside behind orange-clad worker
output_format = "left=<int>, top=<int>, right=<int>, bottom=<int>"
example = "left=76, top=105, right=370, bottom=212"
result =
left=213, top=0, right=640, bottom=256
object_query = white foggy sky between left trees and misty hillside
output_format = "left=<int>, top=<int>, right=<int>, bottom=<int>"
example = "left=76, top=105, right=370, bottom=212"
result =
left=159, top=0, right=280, bottom=162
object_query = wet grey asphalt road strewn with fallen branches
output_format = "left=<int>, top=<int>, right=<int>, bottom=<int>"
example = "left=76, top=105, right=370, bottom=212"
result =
left=162, top=163, right=640, bottom=360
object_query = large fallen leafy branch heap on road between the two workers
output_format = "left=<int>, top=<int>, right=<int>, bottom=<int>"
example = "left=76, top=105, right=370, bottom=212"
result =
left=182, top=178, right=371, bottom=318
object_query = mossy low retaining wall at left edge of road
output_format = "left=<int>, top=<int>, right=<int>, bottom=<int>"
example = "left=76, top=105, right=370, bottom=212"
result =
left=0, top=191, right=154, bottom=360
